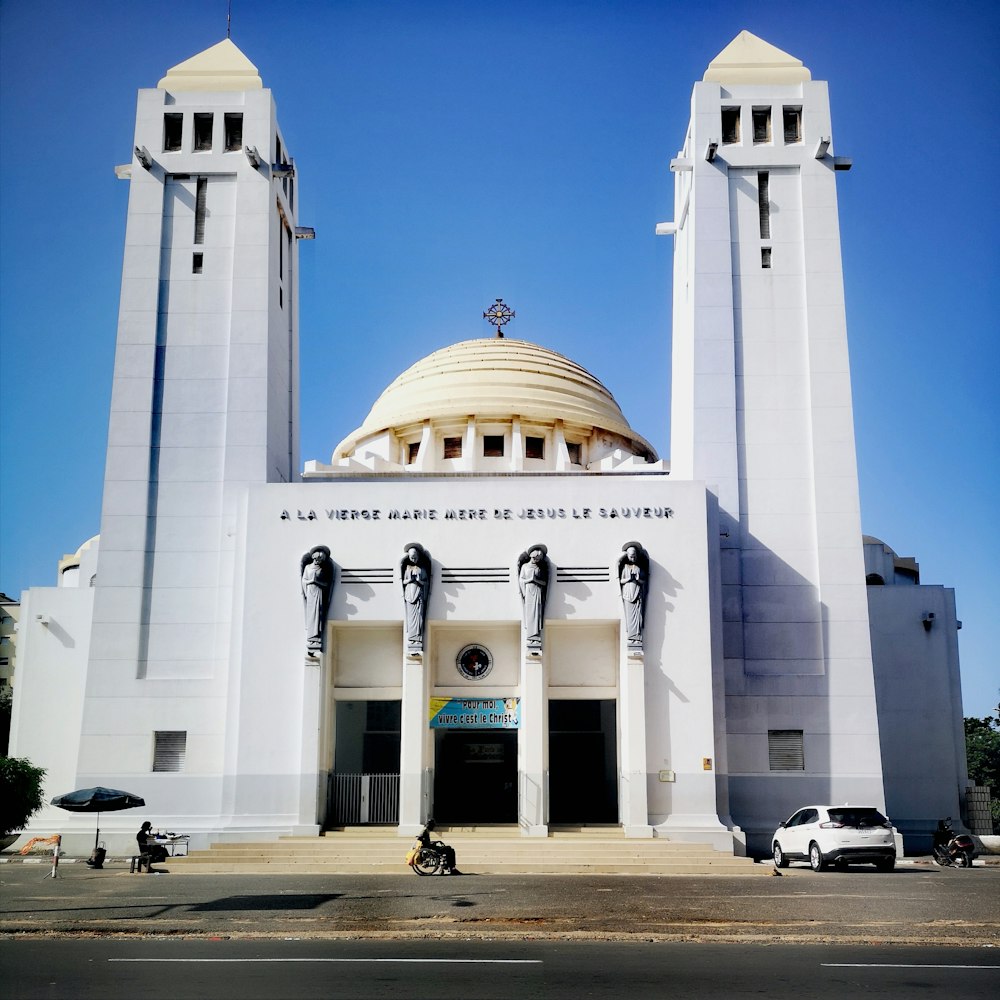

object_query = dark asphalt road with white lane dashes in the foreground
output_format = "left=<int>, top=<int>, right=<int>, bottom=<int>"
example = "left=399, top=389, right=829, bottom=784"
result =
left=0, top=939, right=1000, bottom=1000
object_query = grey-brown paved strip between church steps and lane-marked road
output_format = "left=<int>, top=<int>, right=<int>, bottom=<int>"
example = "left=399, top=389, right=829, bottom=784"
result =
left=0, top=865, right=1000, bottom=944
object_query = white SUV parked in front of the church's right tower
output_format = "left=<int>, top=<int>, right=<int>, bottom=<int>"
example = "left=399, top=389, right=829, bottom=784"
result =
left=771, top=805, right=896, bottom=872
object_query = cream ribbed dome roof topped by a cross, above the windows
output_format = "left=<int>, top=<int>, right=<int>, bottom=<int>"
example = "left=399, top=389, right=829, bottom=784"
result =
left=334, top=337, right=656, bottom=459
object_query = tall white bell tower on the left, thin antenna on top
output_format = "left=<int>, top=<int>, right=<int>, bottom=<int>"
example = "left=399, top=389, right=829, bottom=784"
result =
left=80, top=39, right=302, bottom=788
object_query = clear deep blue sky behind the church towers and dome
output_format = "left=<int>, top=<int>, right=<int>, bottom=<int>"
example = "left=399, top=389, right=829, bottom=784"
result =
left=0, top=0, right=1000, bottom=716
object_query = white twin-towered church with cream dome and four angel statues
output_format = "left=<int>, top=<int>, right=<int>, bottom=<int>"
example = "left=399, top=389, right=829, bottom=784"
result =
left=12, top=32, right=964, bottom=852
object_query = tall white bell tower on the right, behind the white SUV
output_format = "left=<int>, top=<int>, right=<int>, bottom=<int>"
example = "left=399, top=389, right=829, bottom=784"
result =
left=658, top=31, right=883, bottom=830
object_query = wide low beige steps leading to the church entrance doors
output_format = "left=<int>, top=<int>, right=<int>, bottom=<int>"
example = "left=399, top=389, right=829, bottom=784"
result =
left=165, top=826, right=756, bottom=875
